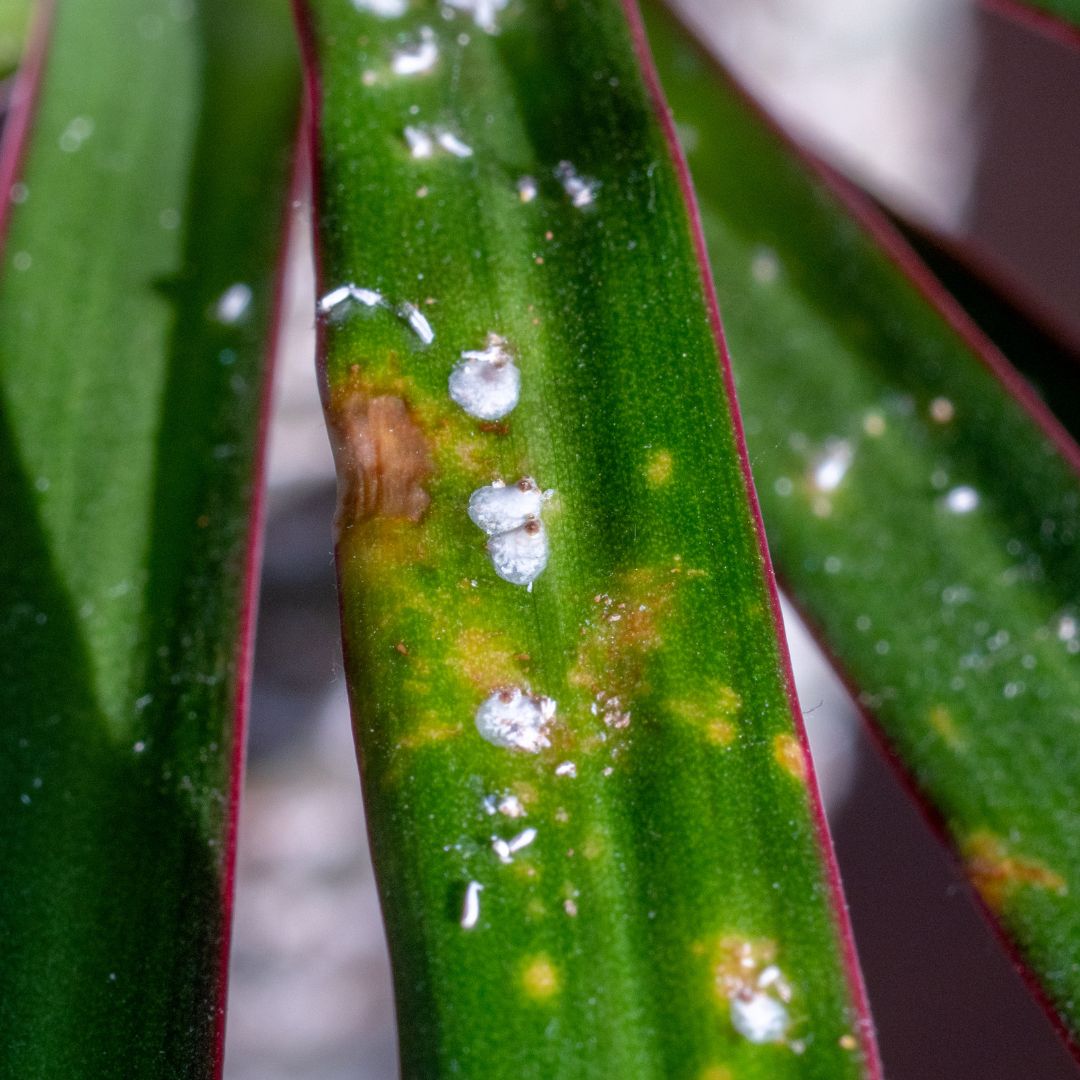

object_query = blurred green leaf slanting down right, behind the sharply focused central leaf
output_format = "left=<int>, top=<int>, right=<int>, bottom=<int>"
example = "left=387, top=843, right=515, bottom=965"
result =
left=648, top=0, right=1080, bottom=1049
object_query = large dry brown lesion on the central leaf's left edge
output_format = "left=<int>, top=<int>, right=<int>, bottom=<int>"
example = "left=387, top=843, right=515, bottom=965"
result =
left=327, top=366, right=432, bottom=536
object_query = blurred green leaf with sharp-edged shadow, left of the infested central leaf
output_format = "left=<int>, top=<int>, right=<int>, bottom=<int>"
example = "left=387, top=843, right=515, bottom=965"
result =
left=0, top=0, right=297, bottom=1078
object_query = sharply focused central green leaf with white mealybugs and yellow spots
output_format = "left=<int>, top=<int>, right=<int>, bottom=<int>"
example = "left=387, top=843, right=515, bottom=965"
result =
left=295, top=0, right=876, bottom=1080
